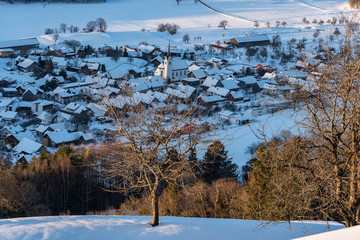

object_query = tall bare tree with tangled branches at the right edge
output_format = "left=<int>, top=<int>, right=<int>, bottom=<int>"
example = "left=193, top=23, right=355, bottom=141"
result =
left=290, top=15, right=360, bottom=227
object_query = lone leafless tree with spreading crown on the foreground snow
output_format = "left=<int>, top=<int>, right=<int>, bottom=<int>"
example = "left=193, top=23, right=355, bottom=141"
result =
left=95, top=90, right=211, bottom=226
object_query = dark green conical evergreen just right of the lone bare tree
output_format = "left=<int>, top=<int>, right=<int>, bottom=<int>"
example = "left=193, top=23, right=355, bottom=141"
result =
left=201, top=140, right=238, bottom=183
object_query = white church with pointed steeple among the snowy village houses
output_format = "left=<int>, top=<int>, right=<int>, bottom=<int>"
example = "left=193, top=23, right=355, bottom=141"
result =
left=155, top=44, right=188, bottom=82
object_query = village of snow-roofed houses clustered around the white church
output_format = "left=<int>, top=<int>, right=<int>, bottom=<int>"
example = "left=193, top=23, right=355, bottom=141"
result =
left=0, top=35, right=306, bottom=163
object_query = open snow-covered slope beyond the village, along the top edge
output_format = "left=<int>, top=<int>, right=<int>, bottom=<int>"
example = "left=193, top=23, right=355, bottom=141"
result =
left=0, top=0, right=349, bottom=44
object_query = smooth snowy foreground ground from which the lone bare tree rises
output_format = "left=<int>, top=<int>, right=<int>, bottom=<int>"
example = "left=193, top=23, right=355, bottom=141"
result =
left=0, top=216, right=344, bottom=240
